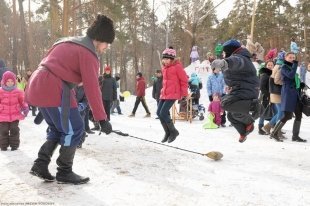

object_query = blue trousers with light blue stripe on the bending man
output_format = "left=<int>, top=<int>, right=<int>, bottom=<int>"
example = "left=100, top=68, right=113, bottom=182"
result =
left=40, top=107, right=84, bottom=147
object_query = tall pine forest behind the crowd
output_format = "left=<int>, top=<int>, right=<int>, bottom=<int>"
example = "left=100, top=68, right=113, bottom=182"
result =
left=0, top=0, right=310, bottom=91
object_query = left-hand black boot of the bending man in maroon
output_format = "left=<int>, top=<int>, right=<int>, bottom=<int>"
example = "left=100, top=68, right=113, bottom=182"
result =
left=30, top=140, right=58, bottom=182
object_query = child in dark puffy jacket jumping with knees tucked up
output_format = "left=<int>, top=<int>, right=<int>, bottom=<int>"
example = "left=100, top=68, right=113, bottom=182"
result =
left=219, top=39, right=259, bottom=143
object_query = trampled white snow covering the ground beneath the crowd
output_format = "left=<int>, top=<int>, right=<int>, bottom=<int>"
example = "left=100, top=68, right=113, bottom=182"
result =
left=0, top=63, right=310, bottom=206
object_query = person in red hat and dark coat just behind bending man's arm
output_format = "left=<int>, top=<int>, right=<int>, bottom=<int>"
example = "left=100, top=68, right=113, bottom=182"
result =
left=99, top=66, right=117, bottom=120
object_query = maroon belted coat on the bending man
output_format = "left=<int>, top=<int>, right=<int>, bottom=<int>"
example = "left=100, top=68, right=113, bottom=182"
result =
left=25, top=42, right=107, bottom=121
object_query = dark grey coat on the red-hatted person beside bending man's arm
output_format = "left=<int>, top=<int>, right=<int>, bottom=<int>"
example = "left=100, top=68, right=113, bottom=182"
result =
left=100, top=74, right=117, bottom=101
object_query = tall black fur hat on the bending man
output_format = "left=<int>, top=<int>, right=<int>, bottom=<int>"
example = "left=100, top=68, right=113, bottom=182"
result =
left=87, top=14, right=115, bottom=44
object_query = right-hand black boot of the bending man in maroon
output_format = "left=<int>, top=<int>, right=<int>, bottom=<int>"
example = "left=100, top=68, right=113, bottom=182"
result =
left=56, top=146, right=89, bottom=185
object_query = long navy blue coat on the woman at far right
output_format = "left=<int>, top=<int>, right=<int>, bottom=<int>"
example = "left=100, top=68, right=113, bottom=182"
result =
left=281, top=61, right=298, bottom=112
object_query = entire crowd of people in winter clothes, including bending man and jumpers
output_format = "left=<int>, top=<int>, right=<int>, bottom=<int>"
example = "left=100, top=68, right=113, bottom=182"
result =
left=0, top=15, right=310, bottom=184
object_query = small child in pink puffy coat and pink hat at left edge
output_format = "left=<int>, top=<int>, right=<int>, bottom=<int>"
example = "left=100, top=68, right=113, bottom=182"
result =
left=0, top=71, right=29, bottom=151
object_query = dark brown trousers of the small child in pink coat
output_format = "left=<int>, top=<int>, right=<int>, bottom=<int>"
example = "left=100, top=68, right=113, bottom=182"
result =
left=0, top=120, right=20, bottom=149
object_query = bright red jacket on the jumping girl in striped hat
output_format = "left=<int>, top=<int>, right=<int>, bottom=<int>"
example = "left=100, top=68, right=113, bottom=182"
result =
left=160, top=60, right=188, bottom=100
